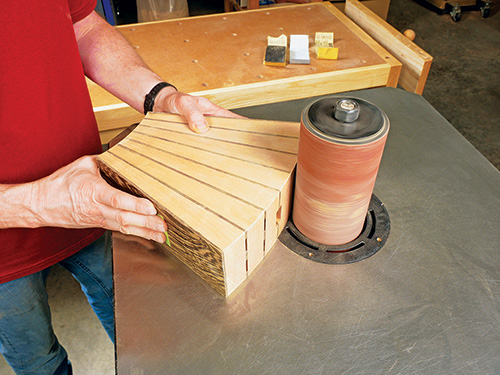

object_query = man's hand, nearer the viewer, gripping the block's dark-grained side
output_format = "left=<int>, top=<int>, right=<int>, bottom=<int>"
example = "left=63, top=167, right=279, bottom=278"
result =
left=30, top=156, right=167, bottom=243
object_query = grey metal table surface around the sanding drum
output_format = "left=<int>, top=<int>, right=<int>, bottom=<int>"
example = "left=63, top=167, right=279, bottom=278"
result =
left=114, top=88, right=500, bottom=375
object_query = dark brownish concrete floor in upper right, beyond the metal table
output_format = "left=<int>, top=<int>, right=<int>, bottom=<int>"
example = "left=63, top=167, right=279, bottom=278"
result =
left=387, top=0, right=500, bottom=169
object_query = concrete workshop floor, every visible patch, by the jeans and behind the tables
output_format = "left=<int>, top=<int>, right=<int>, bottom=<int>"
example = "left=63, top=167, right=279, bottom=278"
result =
left=0, top=0, right=500, bottom=375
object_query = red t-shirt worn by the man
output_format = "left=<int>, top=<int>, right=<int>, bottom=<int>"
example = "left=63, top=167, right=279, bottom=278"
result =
left=0, top=0, right=103, bottom=283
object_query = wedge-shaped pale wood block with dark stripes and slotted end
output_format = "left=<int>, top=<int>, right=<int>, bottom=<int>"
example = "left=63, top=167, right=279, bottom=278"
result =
left=98, top=113, right=300, bottom=297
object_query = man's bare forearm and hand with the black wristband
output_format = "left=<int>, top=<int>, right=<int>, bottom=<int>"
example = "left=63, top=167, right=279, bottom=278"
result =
left=74, top=12, right=239, bottom=133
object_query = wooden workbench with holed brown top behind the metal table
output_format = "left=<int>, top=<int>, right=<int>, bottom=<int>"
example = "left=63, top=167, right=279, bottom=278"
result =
left=88, top=2, right=401, bottom=143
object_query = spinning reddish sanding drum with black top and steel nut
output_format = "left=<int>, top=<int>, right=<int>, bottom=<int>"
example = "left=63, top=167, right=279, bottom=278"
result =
left=293, top=96, right=389, bottom=245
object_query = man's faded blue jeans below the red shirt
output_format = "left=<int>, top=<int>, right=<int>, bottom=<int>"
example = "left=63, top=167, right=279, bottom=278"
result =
left=0, top=232, right=114, bottom=375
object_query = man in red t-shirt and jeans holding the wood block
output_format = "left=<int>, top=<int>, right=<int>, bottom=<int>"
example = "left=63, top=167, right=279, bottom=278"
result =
left=0, top=0, right=238, bottom=374
